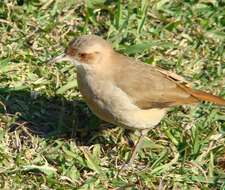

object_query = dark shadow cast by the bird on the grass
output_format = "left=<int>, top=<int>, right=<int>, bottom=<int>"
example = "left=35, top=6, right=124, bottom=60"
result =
left=0, top=88, right=113, bottom=145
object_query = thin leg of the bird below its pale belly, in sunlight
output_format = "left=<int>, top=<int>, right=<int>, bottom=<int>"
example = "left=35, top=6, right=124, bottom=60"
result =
left=126, top=129, right=149, bottom=167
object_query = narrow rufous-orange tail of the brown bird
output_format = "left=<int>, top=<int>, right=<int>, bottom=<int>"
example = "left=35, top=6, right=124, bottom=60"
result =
left=189, top=89, right=225, bottom=106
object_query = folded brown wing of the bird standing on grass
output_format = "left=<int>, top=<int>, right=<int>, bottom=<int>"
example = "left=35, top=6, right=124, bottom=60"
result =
left=113, top=54, right=199, bottom=109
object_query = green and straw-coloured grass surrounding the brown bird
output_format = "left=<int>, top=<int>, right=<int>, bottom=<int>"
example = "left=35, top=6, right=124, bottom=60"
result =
left=0, top=0, right=225, bottom=190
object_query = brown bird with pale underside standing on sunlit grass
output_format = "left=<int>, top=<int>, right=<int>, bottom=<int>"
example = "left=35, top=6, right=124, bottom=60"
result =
left=50, top=35, right=225, bottom=168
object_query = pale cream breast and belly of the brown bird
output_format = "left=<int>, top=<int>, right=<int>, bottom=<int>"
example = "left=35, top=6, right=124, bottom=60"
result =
left=77, top=66, right=165, bottom=129
